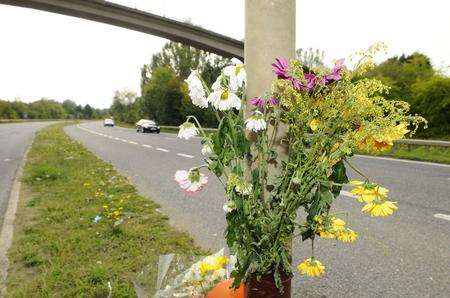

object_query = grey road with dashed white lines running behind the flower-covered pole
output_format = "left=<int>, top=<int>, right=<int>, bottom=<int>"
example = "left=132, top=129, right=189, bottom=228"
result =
left=66, top=122, right=450, bottom=297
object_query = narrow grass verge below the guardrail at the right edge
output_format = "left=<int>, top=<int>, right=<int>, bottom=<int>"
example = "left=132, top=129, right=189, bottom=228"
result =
left=361, top=144, right=450, bottom=164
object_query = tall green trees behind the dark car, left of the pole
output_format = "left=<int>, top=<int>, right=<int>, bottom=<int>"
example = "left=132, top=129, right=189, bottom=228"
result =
left=116, top=41, right=228, bottom=127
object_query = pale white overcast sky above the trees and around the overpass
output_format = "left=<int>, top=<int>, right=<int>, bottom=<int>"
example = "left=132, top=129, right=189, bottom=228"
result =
left=0, top=0, right=450, bottom=108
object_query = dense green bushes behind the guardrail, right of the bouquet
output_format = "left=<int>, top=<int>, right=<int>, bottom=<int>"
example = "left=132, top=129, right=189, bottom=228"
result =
left=368, top=53, right=450, bottom=138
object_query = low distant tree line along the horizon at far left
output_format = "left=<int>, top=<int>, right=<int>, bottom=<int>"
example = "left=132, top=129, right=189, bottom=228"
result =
left=0, top=98, right=108, bottom=119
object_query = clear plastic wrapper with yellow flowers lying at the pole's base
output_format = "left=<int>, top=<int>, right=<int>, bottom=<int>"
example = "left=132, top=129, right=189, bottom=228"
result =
left=134, top=249, right=235, bottom=298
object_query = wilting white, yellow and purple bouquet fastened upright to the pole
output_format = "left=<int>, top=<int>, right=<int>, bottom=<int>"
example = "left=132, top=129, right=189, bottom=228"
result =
left=175, top=44, right=425, bottom=289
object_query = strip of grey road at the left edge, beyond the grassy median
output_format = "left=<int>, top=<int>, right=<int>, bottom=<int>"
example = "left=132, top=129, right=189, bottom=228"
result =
left=0, top=122, right=51, bottom=230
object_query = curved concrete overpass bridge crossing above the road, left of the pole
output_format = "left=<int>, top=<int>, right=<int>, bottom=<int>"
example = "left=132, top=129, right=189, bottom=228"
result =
left=0, top=0, right=244, bottom=60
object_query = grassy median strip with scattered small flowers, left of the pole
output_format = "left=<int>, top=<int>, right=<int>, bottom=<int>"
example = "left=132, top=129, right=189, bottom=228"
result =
left=7, top=124, right=202, bottom=297
